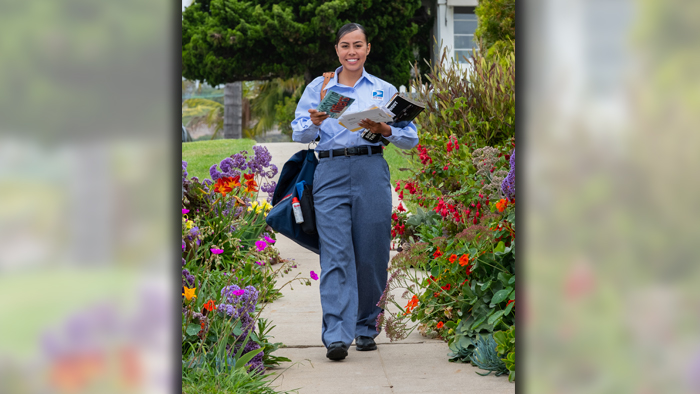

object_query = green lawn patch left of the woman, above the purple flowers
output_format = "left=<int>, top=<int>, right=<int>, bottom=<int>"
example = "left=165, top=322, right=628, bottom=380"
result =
left=182, top=138, right=255, bottom=181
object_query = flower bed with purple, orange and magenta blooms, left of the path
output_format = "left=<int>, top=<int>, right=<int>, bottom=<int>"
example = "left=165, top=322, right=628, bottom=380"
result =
left=182, top=146, right=308, bottom=392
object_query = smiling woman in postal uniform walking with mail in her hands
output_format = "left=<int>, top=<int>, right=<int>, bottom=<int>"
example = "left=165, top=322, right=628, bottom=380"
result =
left=292, top=23, right=418, bottom=360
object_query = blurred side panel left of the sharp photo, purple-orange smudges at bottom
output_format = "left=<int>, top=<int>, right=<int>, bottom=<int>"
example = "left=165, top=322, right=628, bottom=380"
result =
left=0, top=0, right=175, bottom=393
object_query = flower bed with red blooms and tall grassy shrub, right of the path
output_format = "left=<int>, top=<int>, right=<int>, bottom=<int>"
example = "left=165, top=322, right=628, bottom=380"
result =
left=377, top=50, right=515, bottom=380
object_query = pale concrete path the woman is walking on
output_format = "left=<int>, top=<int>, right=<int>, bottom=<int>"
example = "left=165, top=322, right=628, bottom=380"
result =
left=254, top=143, right=515, bottom=394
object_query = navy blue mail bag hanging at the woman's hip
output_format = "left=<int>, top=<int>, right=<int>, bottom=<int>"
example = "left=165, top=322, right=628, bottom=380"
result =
left=265, top=149, right=319, bottom=254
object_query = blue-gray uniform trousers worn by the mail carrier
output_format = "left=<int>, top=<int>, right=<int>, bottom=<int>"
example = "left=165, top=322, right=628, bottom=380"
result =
left=313, top=153, right=392, bottom=347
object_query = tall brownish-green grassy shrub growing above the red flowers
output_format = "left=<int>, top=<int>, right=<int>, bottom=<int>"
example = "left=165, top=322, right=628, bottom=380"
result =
left=413, top=49, right=515, bottom=150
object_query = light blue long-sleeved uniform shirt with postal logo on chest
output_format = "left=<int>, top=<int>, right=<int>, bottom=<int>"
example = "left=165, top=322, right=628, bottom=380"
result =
left=292, top=66, right=418, bottom=151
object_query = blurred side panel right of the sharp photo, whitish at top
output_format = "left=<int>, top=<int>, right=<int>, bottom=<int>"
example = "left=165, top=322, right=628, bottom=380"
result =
left=518, top=0, right=700, bottom=394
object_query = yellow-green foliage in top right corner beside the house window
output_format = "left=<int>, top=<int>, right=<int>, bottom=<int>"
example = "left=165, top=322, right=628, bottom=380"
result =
left=474, top=0, right=515, bottom=57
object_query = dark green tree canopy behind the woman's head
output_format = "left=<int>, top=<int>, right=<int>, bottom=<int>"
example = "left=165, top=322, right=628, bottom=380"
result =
left=182, top=0, right=422, bottom=86
